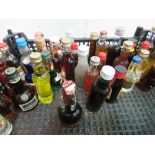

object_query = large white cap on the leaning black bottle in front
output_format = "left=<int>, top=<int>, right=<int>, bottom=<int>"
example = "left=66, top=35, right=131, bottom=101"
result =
left=100, top=65, right=115, bottom=81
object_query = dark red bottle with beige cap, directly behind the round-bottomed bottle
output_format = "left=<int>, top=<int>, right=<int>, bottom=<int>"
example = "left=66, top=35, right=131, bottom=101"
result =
left=61, top=38, right=77, bottom=81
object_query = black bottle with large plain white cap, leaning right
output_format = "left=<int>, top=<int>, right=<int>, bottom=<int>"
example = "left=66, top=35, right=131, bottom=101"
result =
left=86, top=65, right=115, bottom=112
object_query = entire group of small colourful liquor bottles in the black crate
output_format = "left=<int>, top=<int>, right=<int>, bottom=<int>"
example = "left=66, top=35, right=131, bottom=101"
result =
left=0, top=27, right=155, bottom=134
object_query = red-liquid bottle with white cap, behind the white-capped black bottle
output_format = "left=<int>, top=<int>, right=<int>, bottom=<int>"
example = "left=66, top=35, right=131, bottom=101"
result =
left=84, top=56, right=100, bottom=95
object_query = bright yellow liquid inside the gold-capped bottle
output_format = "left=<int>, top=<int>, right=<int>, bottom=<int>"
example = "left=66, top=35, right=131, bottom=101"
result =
left=32, top=71, right=53, bottom=104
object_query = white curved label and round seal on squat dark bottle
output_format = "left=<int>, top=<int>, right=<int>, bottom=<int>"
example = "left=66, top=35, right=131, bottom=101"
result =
left=19, top=94, right=38, bottom=111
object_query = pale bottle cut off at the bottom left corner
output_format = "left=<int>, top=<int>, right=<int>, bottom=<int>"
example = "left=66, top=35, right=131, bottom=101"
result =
left=0, top=114, right=13, bottom=135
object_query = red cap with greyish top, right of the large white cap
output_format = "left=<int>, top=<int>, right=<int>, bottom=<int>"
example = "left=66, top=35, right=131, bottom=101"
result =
left=115, top=65, right=127, bottom=79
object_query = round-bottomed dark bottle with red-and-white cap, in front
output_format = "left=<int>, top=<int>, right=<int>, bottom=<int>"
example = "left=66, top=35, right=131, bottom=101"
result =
left=58, top=80, right=82, bottom=126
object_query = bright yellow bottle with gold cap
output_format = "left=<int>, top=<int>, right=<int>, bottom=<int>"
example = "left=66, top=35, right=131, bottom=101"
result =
left=30, top=52, right=53, bottom=104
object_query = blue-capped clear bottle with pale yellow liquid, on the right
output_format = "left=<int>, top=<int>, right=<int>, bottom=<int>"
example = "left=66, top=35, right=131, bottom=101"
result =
left=122, top=55, right=141, bottom=92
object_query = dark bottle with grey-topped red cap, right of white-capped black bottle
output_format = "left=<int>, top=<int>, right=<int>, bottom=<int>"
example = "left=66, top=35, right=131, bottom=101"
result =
left=106, top=65, right=127, bottom=103
